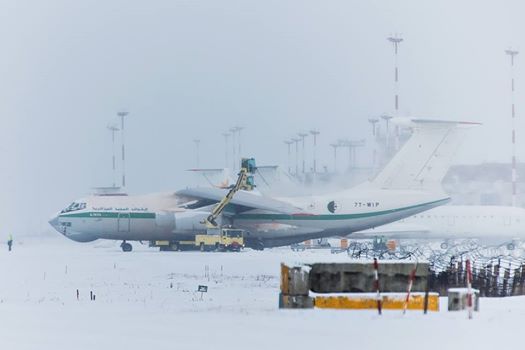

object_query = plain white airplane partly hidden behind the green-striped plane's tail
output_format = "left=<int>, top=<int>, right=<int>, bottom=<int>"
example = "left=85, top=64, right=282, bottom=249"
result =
left=351, top=205, right=525, bottom=250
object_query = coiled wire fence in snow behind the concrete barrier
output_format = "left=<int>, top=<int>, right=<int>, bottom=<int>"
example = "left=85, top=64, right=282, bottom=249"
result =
left=347, top=240, right=525, bottom=297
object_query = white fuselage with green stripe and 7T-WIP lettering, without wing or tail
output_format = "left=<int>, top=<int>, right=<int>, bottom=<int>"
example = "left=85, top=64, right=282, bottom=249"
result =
left=50, top=189, right=448, bottom=246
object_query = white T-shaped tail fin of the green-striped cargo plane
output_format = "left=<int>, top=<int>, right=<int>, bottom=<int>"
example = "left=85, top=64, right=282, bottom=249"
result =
left=371, top=118, right=479, bottom=190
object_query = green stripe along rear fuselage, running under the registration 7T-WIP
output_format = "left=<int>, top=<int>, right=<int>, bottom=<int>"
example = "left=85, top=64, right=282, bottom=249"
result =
left=234, top=198, right=450, bottom=220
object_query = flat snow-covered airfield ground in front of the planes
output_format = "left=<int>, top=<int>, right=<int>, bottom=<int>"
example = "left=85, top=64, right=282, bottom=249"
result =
left=0, top=236, right=525, bottom=350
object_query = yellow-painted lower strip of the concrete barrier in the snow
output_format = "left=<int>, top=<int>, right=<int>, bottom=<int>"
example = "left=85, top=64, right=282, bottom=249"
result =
left=314, top=293, right=439, bottom=311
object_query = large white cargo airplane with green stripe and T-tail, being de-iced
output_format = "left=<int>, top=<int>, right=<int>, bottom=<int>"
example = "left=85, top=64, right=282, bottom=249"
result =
left=49, top=118, right=479, bottom=251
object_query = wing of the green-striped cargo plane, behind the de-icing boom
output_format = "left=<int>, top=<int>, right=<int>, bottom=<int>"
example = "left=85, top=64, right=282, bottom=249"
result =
left=175, top=187, right=304, bottom=215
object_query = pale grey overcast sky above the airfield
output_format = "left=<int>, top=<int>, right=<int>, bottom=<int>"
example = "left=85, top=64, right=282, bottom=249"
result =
left=0, top=0, right=525, bottom=235
